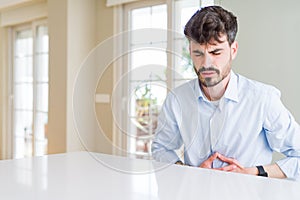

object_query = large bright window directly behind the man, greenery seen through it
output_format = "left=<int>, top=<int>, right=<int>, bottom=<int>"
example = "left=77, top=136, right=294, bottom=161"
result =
left=115, top=0, right=214, bottom=158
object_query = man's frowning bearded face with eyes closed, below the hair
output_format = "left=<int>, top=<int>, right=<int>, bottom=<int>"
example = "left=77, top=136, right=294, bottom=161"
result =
left=190, top=36, right=237, bottom=87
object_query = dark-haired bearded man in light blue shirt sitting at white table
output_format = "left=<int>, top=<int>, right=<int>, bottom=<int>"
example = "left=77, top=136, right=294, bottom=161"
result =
left=152, top=6, right=300, bottom=179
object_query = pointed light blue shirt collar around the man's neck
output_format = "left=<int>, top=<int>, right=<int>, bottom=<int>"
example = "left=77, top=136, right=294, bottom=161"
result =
left=194, top=70, right=239, bottom=102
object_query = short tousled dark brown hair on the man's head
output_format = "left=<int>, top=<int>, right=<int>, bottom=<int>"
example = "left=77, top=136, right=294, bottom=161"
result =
left=184, top=6, right=238, bottom=45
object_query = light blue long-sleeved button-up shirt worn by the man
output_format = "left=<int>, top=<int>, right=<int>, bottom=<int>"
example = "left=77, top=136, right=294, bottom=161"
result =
left=152, top=71, right=300, bottom=179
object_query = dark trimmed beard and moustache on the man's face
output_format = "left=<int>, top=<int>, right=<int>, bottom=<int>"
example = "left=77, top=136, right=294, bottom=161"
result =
left=193, top=56, right=232, bottom=87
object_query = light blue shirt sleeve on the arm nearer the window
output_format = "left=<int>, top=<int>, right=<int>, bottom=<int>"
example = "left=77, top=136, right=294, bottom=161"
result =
left=151, top=93, right=182, bottom=163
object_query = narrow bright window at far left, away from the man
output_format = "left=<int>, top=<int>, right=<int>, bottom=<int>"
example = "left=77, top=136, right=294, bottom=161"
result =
left=11, top=22, right=49, bottom=158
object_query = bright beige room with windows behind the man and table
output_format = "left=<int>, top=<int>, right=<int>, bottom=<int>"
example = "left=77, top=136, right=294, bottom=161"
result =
left=0, top=0, right=300, bottom=197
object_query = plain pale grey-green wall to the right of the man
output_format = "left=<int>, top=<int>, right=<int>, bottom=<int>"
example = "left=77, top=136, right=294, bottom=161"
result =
left=221, top=0, right=300, bottom=123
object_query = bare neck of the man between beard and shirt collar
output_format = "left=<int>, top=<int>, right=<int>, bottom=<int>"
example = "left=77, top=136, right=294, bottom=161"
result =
left=200, top=74, right=230, bottom=101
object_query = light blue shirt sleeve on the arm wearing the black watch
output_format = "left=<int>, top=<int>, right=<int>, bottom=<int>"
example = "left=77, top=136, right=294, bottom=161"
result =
left=264, top=87, right=300, bottom=180
